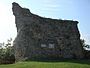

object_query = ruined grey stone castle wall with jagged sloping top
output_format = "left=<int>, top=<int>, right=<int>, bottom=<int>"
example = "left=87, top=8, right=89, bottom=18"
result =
left=12, top=2, right=83, bottom=60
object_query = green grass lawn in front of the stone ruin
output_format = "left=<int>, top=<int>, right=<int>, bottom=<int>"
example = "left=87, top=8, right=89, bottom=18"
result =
left=0, top=60, right=90, bottom=68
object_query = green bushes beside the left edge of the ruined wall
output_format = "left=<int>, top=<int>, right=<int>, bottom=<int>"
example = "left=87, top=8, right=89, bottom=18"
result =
left=0, top=39, right=15, bottom=64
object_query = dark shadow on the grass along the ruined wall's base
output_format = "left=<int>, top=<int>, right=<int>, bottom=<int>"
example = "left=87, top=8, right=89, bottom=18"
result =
left=25, top=59, right=90, bottom=65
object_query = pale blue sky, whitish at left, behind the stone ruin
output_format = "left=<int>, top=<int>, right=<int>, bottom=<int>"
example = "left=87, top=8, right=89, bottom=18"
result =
left=0, top=0, right=90, bottom=45
